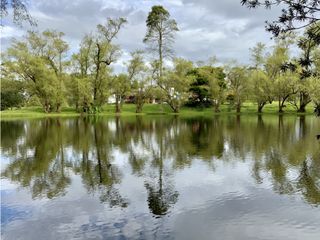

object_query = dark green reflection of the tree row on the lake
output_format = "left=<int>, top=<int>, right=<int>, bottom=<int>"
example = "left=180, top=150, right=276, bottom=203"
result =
left=1, top=116, right=320, bottom=208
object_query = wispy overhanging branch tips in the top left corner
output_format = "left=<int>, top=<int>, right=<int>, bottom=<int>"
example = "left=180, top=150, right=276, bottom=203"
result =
left=0, top=0, right=37, bottom=26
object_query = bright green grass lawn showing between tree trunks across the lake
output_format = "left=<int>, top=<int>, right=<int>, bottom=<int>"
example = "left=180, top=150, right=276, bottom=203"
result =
left=0, top=102, right=313, bottom=118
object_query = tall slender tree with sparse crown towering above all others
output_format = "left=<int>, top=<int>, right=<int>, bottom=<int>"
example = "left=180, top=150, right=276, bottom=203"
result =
left=143, top=6, right=179, bottom=78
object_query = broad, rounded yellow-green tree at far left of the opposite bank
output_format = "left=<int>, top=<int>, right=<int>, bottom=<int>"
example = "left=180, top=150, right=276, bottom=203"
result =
left=3, top=31, right=68, bottom=112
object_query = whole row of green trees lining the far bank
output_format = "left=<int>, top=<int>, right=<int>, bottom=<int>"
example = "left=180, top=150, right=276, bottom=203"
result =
left=1, top=6, right=320, bottom=113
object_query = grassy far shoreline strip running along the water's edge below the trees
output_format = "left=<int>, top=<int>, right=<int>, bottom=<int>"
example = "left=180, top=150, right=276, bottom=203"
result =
left=0, top=103, right=314, bottom=120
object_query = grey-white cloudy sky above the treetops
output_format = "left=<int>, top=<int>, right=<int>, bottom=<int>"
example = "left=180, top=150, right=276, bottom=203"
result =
left=1, top=0, right=279, bottom=71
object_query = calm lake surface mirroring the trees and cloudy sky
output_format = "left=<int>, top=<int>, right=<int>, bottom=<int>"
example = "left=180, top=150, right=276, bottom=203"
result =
left=1, top=116, right=320, bottom=240
